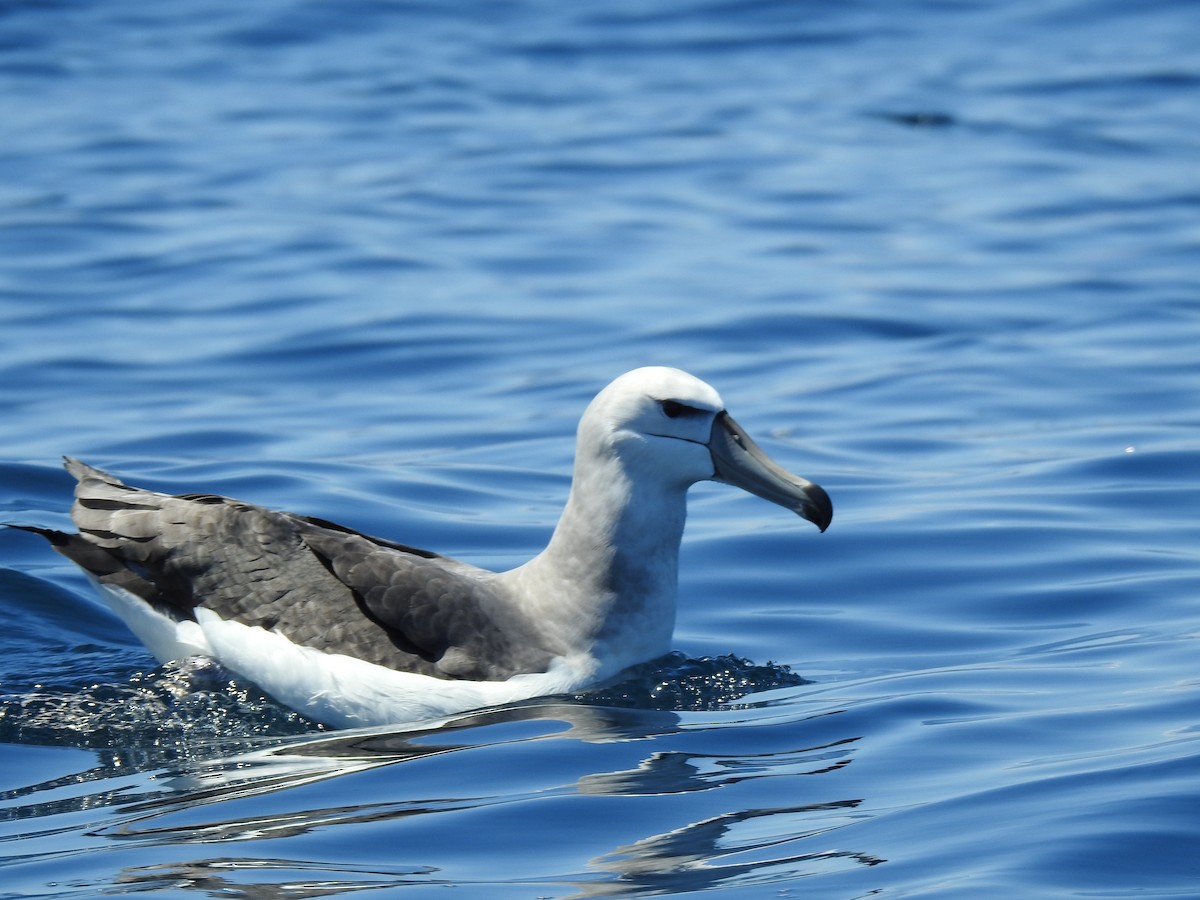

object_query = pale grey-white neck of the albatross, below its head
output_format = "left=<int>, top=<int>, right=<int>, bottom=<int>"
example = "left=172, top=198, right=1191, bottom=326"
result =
left=504, top=451, right=686, bottom=678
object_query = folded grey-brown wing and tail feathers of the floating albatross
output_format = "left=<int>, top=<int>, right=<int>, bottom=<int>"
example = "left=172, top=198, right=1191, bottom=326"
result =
left=52, top=460, right=548, bottom=679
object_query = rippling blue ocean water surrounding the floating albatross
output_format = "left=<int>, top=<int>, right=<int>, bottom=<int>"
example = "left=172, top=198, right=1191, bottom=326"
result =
left=0, top=0, right=1200, bottom=899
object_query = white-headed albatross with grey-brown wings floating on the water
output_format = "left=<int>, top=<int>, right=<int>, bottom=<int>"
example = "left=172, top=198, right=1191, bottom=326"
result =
left=14, top=367, right=833, bottom=727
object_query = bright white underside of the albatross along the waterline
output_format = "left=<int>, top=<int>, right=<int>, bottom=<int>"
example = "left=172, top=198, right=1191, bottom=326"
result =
left=97, top=584, right=596, bottom=728
